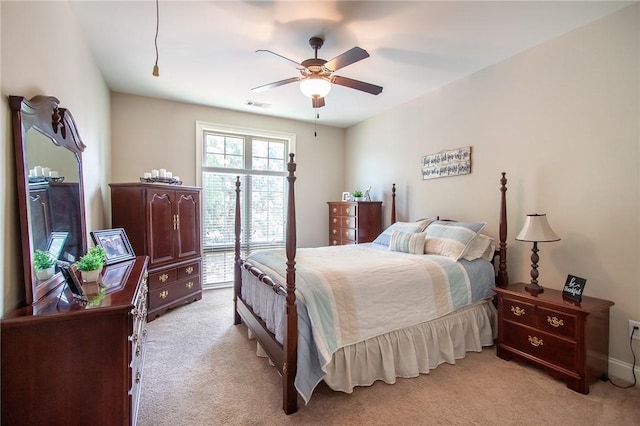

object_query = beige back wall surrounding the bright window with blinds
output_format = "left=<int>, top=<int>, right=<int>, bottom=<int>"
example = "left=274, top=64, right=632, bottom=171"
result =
left=111, top=93, right=345, bottom=247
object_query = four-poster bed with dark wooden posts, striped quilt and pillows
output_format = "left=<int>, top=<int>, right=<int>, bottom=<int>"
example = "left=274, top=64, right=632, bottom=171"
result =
left=234, top=154, right=508, bottom=414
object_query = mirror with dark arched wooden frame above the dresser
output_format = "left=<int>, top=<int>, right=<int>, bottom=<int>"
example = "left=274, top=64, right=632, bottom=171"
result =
left=9, top=96, right=87, bottom=305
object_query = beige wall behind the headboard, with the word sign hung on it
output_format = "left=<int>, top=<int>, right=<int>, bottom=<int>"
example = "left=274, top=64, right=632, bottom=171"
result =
left=346, top=5, right=640, bottom=378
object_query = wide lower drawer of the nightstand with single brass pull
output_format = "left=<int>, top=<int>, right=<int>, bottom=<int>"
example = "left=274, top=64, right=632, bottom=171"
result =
left=503, top=322, right=578, bottom=371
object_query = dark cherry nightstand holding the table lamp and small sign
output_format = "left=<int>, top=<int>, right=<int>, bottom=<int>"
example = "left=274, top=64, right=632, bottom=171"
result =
left=495, top=283, right=613, bottom=394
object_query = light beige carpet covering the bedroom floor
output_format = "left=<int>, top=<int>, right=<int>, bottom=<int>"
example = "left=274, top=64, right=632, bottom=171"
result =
left=138, top=289, right=640, bottom=426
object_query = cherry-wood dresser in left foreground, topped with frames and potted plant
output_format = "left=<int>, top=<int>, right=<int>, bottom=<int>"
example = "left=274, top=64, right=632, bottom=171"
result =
left=0, top=256, right=147, bottom=426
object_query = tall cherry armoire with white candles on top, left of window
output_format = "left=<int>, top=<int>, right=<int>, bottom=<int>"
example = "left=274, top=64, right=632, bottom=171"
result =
left=110, top=182, right=202, bottom=321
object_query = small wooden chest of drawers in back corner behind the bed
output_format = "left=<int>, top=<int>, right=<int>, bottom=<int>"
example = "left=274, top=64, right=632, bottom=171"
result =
left=327, top=201, right=382, bottom=246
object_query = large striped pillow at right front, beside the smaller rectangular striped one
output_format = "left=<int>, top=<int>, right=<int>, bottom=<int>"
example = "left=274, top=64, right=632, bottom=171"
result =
left=424, top=221, right=486, bottom=261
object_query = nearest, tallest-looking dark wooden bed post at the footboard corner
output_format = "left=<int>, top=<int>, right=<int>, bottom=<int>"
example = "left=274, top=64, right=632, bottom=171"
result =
left=282, top=154, right=298, bottom=414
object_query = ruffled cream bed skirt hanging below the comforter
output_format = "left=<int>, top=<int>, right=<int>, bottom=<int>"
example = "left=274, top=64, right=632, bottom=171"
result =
left=243, top=285, right=497, bottom=393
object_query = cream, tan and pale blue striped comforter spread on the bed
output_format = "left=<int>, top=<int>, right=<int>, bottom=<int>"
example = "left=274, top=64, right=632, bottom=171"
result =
left=243, top=244, right=495, bottom=400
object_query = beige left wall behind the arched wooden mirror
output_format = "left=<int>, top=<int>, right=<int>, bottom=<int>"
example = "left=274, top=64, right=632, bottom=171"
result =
left=0, top=2, right=110, bottom=313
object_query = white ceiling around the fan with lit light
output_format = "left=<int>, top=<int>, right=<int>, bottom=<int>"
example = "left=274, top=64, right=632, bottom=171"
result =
left=70, top=0, right=631, bottom=127
